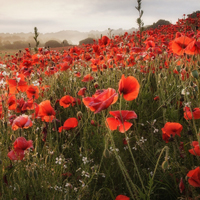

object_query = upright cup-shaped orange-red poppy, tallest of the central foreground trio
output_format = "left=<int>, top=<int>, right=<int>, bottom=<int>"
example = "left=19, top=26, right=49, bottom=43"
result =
left=118, top=74, right=140, bottom=101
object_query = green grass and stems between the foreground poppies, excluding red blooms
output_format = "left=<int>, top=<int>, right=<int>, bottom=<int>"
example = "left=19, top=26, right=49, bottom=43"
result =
left=0, top=46, right=200, bottom=200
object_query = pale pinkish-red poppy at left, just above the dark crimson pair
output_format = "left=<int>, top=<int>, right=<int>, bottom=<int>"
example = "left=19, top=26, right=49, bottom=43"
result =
left=12, top=115, right=33, bottom=131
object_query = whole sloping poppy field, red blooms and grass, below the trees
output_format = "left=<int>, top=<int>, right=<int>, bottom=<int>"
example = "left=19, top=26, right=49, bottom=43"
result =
left=0, top=14, right=200, bottom=200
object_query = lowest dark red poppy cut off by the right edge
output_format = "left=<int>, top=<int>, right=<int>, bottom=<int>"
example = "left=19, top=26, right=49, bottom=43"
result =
left=187, top=167, right=200, bottom=187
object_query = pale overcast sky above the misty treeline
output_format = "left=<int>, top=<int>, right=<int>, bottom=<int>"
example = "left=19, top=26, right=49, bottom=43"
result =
left=0, top=0, right=200, bottom=33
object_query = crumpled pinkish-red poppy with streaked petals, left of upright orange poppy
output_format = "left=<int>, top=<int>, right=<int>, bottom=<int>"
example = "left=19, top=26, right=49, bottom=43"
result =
left=83, top=88, right=118, bottom=114
